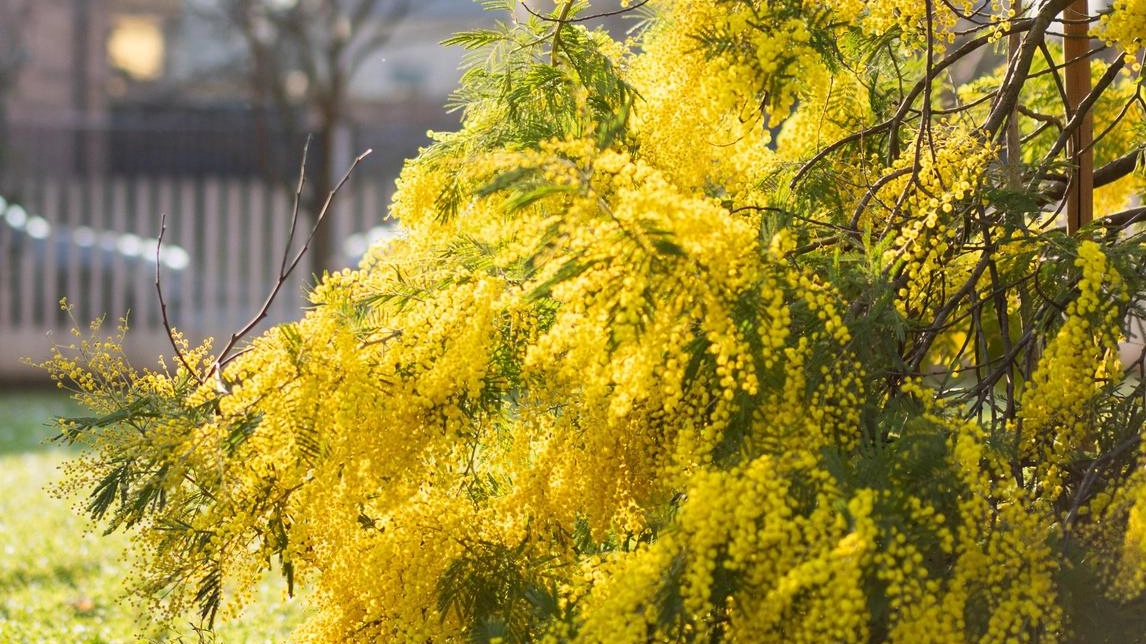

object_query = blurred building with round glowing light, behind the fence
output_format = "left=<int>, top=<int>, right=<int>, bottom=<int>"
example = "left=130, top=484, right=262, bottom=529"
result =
left=0, top=0, right=490, bottom=182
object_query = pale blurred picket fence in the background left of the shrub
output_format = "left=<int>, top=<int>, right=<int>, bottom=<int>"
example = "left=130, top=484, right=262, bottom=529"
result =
left=0, top=173, right=388, bottom=383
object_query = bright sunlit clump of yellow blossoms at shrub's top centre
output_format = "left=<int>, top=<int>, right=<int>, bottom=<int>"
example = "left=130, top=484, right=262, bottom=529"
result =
left=626, top=0, right=825, bottom=194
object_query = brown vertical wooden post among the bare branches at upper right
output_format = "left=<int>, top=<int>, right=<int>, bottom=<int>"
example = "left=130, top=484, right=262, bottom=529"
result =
left=1062, top=0, right=1094, bottom=234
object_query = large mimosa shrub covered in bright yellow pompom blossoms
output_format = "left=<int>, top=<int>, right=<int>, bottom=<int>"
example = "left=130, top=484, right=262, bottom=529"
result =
left=47, top=0, right=1146, bottom=643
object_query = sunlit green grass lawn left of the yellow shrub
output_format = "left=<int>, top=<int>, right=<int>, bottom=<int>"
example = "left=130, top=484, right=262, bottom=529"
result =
left=0, top=390, right=301, bottom=644
